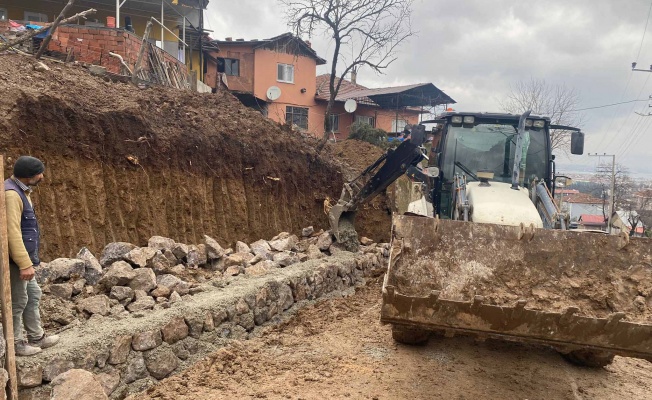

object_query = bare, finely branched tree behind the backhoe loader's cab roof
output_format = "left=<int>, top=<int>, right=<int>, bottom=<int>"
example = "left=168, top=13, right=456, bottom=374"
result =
left=500, top=78, right=583, bottom=153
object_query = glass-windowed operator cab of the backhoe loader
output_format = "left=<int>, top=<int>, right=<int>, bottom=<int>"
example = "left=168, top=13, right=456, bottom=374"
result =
left=430, top=113, right=553, bottom=218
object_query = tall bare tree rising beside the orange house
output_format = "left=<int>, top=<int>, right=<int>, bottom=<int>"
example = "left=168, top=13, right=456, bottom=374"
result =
left=279, top=0, right=414, bottom=148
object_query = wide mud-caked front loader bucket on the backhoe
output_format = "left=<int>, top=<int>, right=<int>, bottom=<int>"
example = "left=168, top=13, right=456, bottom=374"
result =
left=381, top=215, right=652, bottom=360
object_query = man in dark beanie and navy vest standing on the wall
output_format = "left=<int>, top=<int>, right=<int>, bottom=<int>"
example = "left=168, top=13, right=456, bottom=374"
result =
left=5, top=156, right=59, bottom=356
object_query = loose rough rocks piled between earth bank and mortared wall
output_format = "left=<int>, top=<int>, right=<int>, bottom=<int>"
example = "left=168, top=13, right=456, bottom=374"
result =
left=37, top=227, right=389, bottom=329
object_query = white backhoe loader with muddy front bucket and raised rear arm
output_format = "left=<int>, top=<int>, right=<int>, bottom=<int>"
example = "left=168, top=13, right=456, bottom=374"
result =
left=329, top=111, right=652, bottom=367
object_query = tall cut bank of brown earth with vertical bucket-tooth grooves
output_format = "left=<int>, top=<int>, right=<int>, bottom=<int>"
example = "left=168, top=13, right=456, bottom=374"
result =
left=0, top=55, right=389, bottom=261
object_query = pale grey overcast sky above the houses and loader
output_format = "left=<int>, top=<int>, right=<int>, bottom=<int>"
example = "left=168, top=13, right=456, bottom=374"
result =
left=205, top=0, right=652, bottom=172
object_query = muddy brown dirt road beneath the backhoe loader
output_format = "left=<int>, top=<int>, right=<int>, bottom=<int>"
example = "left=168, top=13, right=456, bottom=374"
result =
left=134, top=281, right=652, bottom=400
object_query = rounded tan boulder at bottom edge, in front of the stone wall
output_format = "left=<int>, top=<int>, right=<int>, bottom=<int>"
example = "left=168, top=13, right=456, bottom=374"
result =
left=50, top=369, right=108, bottom=400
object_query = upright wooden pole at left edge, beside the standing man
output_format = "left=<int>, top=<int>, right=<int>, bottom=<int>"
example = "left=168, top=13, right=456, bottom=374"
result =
left=0, top=155, right=18, bottom=400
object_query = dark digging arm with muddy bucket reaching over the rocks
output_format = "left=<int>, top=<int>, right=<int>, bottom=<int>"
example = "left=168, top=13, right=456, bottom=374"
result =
left=328, top=125, right=425, bottom=250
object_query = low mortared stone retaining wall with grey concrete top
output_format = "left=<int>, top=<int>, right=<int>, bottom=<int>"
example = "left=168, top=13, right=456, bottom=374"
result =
left=18, top=251, right=385, bottom=399
